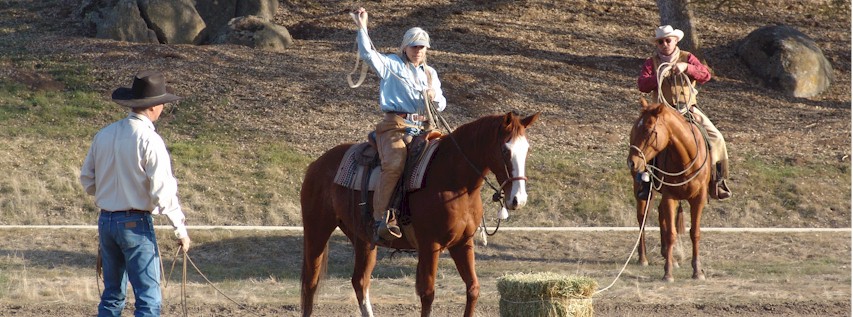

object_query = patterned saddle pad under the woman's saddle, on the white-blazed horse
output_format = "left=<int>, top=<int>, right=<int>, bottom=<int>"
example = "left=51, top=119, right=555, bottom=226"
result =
left=335, top=140, right=439, bottom=191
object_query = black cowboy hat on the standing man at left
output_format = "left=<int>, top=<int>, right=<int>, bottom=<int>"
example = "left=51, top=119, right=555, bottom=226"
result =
left=112, top=70, right=181, bottom=108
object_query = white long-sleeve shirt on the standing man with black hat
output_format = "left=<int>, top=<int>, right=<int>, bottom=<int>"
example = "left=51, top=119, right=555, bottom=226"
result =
left=80, top=112, right=187, bottom=238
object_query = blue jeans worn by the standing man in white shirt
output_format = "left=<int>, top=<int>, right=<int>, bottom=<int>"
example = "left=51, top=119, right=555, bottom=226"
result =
left=98, top=211, right=162, bottom=317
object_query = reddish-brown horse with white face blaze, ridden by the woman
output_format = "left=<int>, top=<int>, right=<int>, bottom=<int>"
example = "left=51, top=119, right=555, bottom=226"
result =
left=301, top=113, right=539, bottom=316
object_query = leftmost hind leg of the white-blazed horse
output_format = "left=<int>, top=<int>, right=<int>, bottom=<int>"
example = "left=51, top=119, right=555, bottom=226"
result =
left=301, top=214, right=336, bottom=316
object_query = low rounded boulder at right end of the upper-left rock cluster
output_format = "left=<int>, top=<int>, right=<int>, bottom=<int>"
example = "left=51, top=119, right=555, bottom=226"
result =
left=211, top=15, right=293, bottom=52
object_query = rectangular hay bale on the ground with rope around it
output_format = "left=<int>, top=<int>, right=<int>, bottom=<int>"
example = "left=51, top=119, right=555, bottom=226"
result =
left=498, top=272, right=598, bottom=317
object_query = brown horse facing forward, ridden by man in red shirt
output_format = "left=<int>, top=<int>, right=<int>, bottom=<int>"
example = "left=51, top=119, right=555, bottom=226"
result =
left=628, top=99, right=711, bottom=282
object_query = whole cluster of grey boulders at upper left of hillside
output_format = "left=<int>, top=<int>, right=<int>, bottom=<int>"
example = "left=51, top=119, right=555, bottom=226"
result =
left=76, top=0, right=293, bottom=51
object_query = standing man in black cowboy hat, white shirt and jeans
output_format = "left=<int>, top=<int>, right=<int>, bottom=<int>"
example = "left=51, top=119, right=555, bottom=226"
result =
left=80, top=71, right=190, bottom=316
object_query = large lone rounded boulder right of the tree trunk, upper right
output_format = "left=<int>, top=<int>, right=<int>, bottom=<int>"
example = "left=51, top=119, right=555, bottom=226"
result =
left=738, top=25, right=832, bottom=98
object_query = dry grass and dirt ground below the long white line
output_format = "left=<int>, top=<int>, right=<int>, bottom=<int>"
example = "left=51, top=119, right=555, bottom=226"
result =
left=0, top=230, right=851, bottom=317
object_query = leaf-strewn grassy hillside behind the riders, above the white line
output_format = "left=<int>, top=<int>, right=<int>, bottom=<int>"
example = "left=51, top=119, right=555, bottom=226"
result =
left=0, top=0, right=851, bottom=227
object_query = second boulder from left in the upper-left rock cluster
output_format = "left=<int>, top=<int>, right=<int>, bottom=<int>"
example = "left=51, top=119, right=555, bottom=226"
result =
left=139, top=0, right=205, bottom=44
